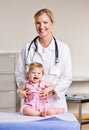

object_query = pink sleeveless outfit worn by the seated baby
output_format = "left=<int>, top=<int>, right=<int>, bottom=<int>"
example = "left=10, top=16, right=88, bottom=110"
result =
left=21, top=81, right=50, bottom=114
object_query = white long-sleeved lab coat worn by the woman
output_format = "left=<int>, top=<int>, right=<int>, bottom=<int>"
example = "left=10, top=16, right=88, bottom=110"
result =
left=15, top=36, right=72, bottom=111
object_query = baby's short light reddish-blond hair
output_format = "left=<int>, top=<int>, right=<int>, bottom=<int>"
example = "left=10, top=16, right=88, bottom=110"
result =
left=26, top=62, right=44, bottom=78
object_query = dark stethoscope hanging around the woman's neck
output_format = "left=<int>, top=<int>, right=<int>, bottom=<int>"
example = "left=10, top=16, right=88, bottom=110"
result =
left=27, top=36, right=58, bottom=64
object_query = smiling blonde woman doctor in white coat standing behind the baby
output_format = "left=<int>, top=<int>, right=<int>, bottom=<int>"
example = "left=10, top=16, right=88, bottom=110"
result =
left=15, top=9, right=72, bottom=112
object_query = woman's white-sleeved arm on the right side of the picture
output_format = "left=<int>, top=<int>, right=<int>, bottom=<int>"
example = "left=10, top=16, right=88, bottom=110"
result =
left=54, top=43, right=72, bottom=97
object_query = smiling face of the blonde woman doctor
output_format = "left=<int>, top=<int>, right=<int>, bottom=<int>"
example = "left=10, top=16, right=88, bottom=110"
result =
left=35, top=13, right=53, bottom=38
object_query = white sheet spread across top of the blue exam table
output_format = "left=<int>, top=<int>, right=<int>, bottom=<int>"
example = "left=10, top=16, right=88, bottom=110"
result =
left=0, top=112, right=77, bottom=123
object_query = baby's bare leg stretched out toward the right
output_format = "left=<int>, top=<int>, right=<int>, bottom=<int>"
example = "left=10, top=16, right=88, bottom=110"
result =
left=46, top=107, right=65, bottom=116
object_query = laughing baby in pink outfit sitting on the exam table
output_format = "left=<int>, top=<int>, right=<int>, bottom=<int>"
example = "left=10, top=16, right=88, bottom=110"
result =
left=17, top=62, right=64, bottom=116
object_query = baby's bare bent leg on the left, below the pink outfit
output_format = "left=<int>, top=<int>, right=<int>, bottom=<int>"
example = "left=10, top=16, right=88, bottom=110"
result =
left=23, top=107, right=40, bottom=116
